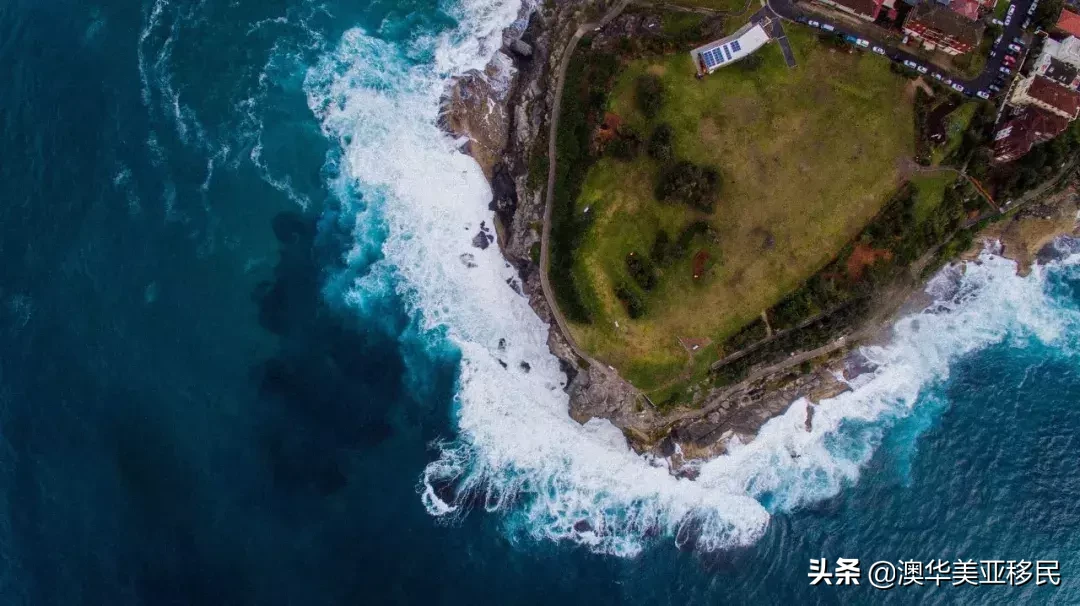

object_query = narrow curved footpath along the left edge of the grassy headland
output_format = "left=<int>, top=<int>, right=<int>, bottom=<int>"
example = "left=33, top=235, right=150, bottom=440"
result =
left=540, top=0, right=631, bottom=372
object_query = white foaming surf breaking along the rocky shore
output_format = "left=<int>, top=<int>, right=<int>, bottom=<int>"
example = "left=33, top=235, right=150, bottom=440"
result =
left=305, top=0, right=1075, bottom=555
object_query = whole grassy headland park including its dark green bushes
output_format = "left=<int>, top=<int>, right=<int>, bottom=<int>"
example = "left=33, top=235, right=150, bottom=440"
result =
left=551, top=27, right=916, bottom=391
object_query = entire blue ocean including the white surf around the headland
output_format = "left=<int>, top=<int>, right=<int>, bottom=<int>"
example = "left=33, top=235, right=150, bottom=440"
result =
left=6, top=0, right=1080, bottom=606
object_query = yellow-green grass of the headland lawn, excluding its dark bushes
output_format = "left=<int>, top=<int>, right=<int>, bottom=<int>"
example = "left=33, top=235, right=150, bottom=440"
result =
left=571, top=26, right=915, bottom=390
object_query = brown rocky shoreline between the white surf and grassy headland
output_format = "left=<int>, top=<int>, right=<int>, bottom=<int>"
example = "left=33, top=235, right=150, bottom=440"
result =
left=443, top=0, right=1080, bottom=476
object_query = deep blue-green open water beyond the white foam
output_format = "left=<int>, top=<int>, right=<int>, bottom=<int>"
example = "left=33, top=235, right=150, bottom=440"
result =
left=6, top=0, right=1080, bottom=605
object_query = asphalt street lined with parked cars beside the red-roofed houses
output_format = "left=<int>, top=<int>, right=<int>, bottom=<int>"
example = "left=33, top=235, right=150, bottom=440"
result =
left=767, top=0, right=1035, bottom=96
